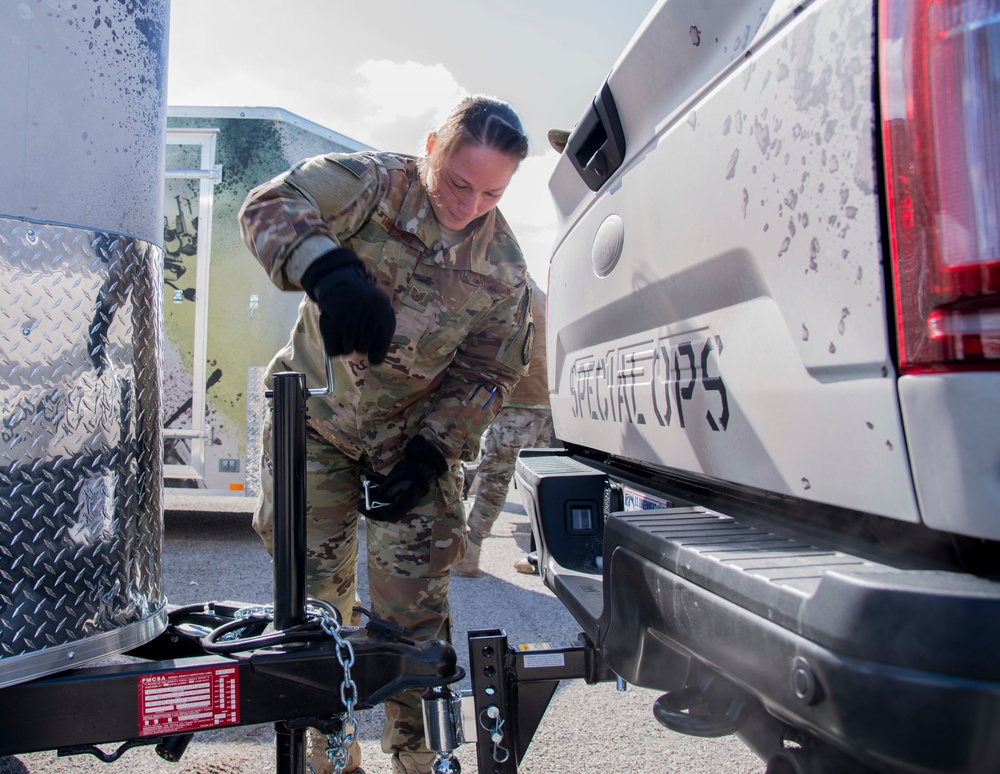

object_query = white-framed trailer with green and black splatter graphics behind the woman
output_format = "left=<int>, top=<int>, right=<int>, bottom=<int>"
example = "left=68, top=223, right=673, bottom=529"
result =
left=163, top=107, right=369, bottom=510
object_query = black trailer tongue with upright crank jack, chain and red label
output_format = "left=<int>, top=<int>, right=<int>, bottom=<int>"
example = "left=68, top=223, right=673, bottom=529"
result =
left=0, top=368, right=465, bottom=774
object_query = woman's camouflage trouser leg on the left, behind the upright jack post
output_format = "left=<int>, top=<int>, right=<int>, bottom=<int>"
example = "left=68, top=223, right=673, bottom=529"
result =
left=253, top=421, right=361, bottom=626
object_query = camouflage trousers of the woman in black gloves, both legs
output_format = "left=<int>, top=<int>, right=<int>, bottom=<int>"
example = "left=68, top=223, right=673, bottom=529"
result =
left=253, top=420, right=466, bottom=754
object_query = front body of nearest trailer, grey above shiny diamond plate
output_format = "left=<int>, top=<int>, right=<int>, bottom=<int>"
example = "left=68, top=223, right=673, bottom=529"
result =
left=0, top=2, right=168, bottom=687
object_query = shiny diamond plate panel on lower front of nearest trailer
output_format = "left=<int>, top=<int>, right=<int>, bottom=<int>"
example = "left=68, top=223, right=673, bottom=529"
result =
left=0, top=218, right=166, bottom=686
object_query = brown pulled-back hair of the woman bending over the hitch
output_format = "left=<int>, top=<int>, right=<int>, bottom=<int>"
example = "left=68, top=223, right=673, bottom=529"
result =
left=417, top=94, right=528, bottom=184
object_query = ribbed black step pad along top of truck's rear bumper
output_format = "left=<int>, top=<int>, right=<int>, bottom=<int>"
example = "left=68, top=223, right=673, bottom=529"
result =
left=604, top=507, right=1000, bottom=679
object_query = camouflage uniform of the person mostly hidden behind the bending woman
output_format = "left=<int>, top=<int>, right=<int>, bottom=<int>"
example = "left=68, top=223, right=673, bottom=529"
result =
left=469, top=279, right=555, bottom=544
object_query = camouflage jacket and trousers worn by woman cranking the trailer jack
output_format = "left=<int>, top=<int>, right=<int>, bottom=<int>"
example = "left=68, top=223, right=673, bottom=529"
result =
left=240, top=153, right=534, bottom=768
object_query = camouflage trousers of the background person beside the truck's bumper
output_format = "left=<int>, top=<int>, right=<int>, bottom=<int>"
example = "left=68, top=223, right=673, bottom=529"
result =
left=469, top=406, right=554, bottom=545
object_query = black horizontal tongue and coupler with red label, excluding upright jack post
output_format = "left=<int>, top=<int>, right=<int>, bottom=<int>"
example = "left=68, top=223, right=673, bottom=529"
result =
left=0, top=600, right=464, bottom=762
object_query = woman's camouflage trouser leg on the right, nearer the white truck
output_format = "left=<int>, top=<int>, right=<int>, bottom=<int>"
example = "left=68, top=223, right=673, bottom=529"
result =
left=366, top=465, right=465, bottom=753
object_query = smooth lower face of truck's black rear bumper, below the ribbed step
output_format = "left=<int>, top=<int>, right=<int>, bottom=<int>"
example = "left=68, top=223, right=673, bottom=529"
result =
left=601, top=548, right=1000, bottom=774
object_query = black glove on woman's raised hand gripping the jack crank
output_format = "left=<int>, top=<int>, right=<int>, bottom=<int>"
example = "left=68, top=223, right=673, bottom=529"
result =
left=301, top=247, right=396, bottom=364
